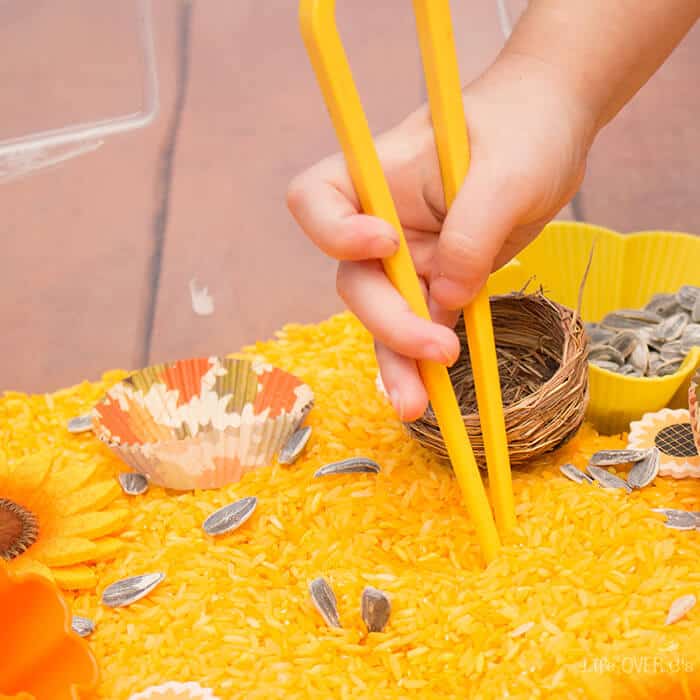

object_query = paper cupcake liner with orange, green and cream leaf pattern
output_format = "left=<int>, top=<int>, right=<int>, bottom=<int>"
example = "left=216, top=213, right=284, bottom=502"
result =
left=95, top=357, right=313, bottom=490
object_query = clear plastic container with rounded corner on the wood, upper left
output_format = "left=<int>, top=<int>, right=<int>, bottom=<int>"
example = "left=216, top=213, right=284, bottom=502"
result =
left=0, top=0, right=158, bottom=183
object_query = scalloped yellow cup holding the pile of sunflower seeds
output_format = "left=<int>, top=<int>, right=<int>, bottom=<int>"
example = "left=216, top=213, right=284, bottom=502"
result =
left=489, top=221, right=700, bottom=434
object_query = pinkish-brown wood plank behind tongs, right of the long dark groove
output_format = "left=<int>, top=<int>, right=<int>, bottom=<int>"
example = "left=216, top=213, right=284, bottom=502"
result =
left=151, top=0, right=508, bottom=361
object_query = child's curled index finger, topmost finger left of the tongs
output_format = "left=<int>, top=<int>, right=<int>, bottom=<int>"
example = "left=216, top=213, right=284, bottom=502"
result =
left=287, top=168, right=399, bottom=260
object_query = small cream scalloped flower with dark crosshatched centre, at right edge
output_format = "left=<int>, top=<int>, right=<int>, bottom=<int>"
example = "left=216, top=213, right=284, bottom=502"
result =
left=628, top=408, right=700, bottom=479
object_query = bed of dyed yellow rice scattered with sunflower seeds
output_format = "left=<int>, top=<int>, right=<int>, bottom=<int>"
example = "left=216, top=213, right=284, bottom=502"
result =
left=4, top=314, right=700, bottom=700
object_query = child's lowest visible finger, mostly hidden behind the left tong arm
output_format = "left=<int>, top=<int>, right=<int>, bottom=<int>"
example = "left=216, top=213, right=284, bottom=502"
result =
left=374, top=342, right=428, bottom=422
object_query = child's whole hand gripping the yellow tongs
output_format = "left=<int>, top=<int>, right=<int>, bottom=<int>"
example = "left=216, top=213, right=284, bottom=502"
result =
left=288, top=57, right=593, bottom=421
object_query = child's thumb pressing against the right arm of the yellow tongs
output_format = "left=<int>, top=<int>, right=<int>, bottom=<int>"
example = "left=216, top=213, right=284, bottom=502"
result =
left=430, top=167, right=523, bottom=309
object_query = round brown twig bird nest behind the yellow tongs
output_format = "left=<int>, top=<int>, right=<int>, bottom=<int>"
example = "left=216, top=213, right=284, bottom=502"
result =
left=406, top=292, right=588, bottom=468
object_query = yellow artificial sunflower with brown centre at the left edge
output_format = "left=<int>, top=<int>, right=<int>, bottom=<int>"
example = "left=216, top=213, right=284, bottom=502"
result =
left=0, top=450, right=129, bottom=589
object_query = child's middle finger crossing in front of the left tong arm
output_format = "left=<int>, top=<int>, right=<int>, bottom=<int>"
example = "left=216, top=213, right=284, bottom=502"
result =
left=337, top=261, right=459, bottom=365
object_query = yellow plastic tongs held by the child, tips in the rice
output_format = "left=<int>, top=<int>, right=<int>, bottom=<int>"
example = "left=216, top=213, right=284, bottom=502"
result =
left=300, top=0, right=515, bottom=562
